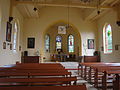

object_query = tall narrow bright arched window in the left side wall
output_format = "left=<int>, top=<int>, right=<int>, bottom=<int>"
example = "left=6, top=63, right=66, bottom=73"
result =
left=13, top=22, right=18, bottom=51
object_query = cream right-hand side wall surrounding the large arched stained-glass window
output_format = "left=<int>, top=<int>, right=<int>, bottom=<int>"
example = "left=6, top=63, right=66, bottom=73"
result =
left=98, top=10, right=120, bottom=62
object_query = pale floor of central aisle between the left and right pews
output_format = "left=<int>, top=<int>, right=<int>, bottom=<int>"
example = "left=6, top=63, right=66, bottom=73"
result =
left=60, top=62, right=98, bottom=90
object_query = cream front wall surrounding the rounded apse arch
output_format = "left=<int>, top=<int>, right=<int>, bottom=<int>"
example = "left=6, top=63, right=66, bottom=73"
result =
left=24, top=7, right=97, bottom=62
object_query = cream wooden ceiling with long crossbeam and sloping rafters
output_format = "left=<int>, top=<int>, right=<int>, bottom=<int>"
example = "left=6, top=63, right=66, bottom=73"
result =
left=11, top=0, right=120, bottom=20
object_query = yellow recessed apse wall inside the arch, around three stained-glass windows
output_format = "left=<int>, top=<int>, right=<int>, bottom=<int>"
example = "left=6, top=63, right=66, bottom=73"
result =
left=44, top=22, right=82, bottom=60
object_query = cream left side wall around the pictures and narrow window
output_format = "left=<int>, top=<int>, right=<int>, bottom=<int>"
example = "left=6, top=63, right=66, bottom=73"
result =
left=0, top=0, right=23, bottom=65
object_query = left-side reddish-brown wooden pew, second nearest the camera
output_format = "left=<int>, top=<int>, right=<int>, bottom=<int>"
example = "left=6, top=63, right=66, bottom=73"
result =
left=0, top=77, right=77, bottom=86
